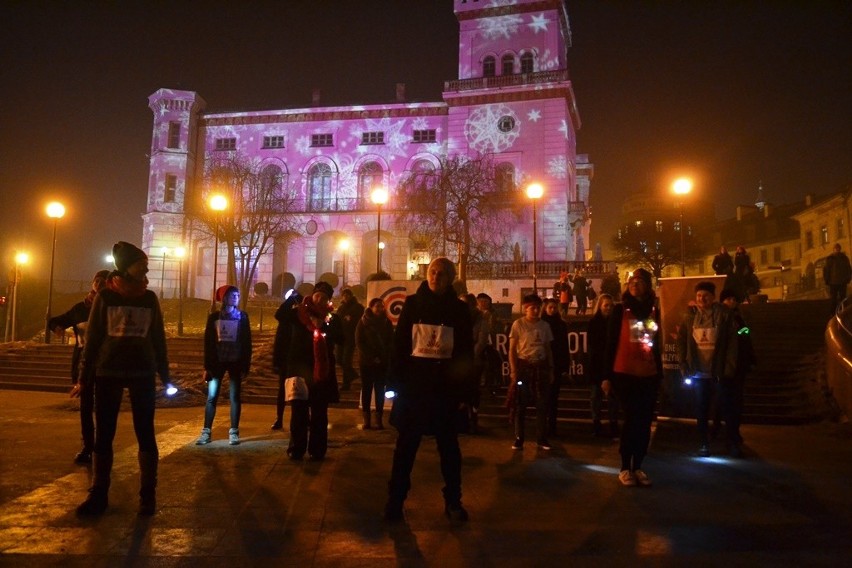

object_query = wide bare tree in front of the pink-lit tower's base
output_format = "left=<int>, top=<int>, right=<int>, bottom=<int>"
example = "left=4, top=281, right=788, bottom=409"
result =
left=395, top=156, right=518, bottom=281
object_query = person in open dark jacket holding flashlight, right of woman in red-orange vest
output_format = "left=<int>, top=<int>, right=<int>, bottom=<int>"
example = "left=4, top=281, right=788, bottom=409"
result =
left=677, top=282, right=737, bottom=457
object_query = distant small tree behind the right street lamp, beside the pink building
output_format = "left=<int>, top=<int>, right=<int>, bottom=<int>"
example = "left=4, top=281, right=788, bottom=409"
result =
left=611, top=221, right=700, bottom=278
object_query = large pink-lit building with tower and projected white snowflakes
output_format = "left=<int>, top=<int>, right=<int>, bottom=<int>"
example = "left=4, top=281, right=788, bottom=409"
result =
left=143, top=0, right=593, bottom=297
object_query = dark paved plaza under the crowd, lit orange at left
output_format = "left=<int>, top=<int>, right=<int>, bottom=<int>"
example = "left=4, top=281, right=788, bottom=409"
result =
left=0, top=391, right=852, bottom=568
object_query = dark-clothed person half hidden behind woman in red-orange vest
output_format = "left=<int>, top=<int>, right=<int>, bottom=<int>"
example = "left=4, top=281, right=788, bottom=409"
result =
left=587, top=294, right=618, bottom=437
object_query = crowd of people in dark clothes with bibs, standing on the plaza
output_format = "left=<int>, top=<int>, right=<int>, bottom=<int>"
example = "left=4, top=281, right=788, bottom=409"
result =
left=63, top=248, right=754, bottom=521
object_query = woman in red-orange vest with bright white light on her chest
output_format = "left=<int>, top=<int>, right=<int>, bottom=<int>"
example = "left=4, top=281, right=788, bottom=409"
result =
left=601, top=268, right=663, bottom=487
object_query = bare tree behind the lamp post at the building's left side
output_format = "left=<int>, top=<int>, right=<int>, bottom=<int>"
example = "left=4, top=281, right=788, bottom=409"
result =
left=198, top=152, right=296, bottom=305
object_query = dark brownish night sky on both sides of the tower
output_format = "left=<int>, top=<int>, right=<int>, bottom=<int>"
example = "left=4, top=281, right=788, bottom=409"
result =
left=0, top=0, right=852, bottom=281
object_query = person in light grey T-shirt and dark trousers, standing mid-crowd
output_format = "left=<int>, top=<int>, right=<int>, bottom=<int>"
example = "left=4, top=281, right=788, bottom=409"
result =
left=506, top=294, right=554, bottom=450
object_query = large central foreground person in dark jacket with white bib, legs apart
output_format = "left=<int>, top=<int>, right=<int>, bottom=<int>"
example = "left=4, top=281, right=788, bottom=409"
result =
left=384, top=258, right=477, bottom=521
